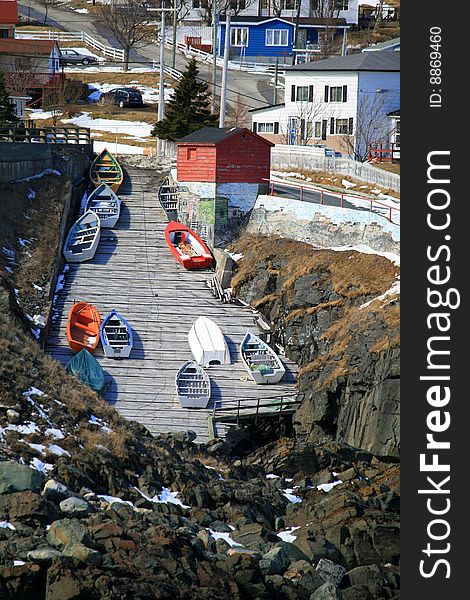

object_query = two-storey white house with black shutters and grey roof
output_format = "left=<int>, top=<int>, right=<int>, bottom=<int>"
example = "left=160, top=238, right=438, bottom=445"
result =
left=250, top=52, right=400, bottom=160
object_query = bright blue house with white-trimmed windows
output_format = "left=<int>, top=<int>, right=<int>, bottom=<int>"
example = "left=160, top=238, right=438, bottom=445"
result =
left=217, top=16, right=349, bottom=62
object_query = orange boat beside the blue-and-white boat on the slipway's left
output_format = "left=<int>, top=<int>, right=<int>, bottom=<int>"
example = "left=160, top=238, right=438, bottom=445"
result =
left=66, top=302, right=101, bottom=352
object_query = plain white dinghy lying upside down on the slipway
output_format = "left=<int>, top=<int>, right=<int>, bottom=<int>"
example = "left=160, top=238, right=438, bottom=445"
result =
left=188, top=317, right=230, bottom=367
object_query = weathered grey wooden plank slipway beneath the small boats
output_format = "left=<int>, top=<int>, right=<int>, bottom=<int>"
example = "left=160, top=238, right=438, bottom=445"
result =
left=46, top=168, right=295, bottom=442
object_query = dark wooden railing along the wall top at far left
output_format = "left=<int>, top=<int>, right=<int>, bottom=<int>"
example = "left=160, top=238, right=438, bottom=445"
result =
left=0, top=126, right=92, bottom=144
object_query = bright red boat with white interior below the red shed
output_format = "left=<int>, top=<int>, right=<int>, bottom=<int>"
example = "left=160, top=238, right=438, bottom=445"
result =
left=165, top=221, right=214, bottom=269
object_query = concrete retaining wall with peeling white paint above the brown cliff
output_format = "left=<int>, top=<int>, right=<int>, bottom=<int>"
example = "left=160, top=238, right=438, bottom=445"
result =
left=247, top=196, right=400, bottom=254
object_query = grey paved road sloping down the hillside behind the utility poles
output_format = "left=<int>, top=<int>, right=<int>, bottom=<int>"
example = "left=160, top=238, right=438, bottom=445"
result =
left=18, top=0, right=282, bottom=117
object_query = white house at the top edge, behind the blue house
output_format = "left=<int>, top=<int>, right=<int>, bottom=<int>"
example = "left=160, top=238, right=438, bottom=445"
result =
left=184, top=0, right=359, bottom=25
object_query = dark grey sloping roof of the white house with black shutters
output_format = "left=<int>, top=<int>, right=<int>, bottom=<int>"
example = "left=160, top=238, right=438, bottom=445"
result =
left=286, top=52, right=400, bottom=73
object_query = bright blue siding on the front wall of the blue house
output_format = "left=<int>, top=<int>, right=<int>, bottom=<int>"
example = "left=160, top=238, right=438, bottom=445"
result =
left=218, top=19, right=294, bottom=58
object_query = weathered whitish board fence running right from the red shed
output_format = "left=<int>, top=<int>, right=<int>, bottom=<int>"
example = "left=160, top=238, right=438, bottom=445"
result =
left=271, top=144, right=400, bottom=192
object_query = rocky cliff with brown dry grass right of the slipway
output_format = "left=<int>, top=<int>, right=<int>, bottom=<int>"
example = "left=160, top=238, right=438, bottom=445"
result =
left=232, top=236, right=400, bottom=457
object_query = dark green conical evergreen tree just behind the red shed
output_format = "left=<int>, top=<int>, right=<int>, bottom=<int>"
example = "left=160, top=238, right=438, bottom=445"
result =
left=152, top=58, right=219, bottom=141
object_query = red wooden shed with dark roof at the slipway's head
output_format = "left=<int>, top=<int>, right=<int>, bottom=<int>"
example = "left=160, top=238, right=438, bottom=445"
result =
left=176, top=127, right=274, bottom=183
